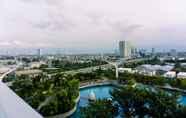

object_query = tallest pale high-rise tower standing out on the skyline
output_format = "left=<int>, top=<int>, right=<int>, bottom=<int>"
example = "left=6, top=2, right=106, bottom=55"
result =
left=119, top=41, right=135, bottom=58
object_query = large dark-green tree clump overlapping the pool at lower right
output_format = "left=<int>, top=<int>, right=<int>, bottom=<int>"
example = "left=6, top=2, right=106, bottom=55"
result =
left=111, top=86, right=183, bottom=118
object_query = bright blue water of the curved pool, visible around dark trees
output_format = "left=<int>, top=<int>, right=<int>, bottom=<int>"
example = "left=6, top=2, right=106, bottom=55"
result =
left=71, top=85, right=186, bottom=118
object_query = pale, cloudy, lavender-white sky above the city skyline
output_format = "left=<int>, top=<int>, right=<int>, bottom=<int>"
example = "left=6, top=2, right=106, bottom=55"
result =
left=0, top=0, right=186, bottom=51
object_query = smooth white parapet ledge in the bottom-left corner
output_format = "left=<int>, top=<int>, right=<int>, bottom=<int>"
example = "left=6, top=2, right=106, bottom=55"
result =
left=0, top=81, right=43, bottom=118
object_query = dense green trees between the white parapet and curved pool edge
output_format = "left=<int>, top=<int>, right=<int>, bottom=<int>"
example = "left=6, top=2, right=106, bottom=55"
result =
left=11, top=74, right=79, bottom=116
